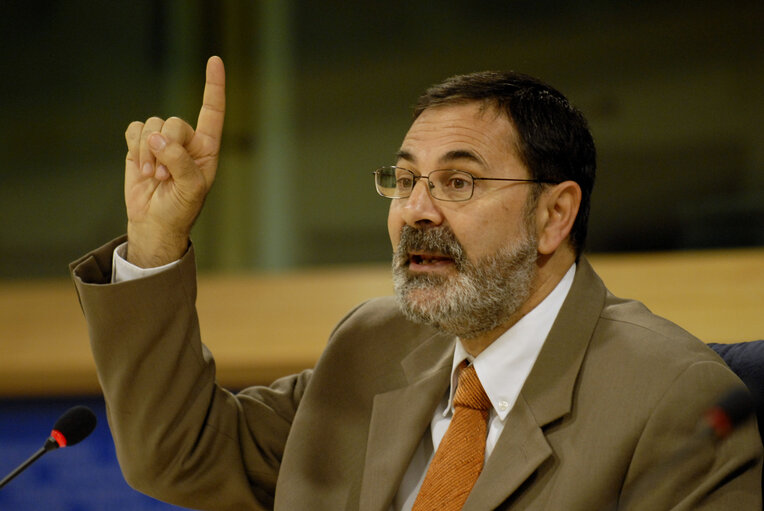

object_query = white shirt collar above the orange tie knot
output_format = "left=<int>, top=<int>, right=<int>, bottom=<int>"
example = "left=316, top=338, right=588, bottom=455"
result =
left=444, top=264, right=576, bottom=421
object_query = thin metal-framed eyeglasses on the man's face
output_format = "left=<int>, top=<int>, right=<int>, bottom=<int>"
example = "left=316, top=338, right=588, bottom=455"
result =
left=374, top=167, right=554, bottom=202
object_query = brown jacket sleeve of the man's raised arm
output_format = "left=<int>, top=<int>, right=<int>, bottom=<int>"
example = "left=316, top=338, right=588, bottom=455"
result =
left=70, top=238, right=311, bottom=510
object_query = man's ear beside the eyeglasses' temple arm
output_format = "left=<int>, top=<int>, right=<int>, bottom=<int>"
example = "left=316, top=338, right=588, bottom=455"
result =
left=536, top=181, right=581, bottom=255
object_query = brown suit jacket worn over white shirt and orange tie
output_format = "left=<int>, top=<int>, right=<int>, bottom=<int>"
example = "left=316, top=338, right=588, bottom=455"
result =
left=72, top=240, right=761, bottom=511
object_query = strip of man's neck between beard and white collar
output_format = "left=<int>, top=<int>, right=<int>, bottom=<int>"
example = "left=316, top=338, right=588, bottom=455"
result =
left=461, top=250, right=576, bottom=357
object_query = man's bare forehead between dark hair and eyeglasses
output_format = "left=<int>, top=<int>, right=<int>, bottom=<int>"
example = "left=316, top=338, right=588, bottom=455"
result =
left=400, top=102, right=517, bottom=167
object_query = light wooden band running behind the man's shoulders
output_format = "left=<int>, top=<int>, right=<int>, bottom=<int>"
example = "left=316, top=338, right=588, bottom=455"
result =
left=0, top=248, right=764, bottom=397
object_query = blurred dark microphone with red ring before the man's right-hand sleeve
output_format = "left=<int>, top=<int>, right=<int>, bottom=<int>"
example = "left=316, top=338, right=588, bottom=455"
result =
left=602, top=387, right=756, bottom=511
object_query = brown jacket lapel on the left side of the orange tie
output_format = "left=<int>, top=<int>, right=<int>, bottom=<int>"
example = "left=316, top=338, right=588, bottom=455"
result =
left=359, top=335, right=454, bottom=511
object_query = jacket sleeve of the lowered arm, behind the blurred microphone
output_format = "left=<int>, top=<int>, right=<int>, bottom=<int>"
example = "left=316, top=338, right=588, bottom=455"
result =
left=618, top=361, right=762, bottom=511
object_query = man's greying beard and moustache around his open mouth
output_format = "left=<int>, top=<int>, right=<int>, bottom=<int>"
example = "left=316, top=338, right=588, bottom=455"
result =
left=393, top=225, right=538, bottom=339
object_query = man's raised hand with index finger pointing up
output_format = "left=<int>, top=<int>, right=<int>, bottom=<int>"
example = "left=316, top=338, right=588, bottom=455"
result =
left=125, top=57, right=225, bottom=268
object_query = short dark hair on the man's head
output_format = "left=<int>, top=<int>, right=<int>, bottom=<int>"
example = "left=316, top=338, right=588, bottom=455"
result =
left=414, top=71, right=597, bottom=255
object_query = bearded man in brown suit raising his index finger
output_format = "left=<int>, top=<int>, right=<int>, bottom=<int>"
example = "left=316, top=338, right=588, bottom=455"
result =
left=72, top=57, right=761, bottom=511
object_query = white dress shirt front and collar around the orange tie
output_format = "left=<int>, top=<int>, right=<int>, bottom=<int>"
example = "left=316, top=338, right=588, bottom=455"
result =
left=390, top=264, right=576, bottom=511
